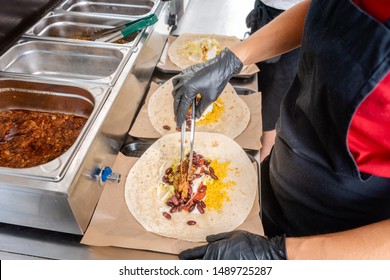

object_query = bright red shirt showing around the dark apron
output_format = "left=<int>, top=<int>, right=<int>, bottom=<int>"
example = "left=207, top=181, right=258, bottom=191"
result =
left=347, top=0, right=390, bottom=178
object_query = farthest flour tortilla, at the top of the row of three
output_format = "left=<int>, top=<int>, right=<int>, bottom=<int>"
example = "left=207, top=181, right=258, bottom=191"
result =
left=168, top=33, right=240, bottom=69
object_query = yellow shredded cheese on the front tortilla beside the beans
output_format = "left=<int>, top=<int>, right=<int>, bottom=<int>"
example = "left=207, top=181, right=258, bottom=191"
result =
left=205, top=160, right=236, bottom=212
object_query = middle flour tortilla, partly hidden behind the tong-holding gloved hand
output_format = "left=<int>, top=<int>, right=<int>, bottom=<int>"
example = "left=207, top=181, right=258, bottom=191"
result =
left=148, top=79, right=250, bottom=139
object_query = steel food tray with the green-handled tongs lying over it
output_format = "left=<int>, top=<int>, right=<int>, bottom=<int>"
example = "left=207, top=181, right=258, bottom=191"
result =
left=24, top=13, right=143, bottom=47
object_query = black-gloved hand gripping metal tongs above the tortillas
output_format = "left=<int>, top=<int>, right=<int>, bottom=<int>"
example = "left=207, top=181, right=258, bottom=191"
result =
left=172, top=48, right=243, bottom=127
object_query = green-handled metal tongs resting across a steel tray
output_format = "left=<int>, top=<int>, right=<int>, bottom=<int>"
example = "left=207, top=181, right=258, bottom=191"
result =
left=91, top=14, right=158, bottom=43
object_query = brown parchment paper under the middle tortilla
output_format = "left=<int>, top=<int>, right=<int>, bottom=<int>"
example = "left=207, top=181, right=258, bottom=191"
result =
left=129, top=83, right=263, bottom=150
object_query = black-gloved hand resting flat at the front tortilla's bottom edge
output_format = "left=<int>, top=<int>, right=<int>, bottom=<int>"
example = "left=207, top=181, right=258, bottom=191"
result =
left=179, top=230, right=287, bottom=260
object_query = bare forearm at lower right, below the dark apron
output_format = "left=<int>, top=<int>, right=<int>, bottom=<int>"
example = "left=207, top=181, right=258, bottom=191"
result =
left=286, top=219, right=390, bottom=260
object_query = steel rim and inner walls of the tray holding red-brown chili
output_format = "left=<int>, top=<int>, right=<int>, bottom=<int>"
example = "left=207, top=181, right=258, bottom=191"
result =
left=0, top=77, right=108, bottom=181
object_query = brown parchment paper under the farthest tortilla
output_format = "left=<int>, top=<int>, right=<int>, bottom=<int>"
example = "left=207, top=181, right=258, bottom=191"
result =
left=157, top=35, right=260, bottom=78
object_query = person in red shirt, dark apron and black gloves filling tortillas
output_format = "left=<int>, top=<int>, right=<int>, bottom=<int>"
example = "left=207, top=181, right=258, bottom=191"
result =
left=172, top=0, right=390, bottom=259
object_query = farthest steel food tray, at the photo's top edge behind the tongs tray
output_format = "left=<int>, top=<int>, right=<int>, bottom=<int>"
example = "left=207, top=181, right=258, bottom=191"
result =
left=55, top=0, right=159, bottom=18
